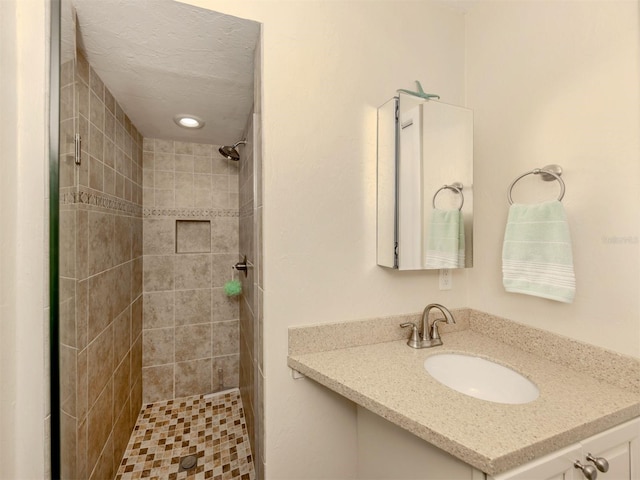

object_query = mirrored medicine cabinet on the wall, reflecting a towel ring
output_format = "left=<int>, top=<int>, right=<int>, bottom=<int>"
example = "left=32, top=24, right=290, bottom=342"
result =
left=377, top=92, right=473, bottom=270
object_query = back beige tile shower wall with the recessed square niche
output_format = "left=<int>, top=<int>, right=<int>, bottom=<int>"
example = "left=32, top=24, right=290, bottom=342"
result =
left=143, top=138, right=239, bottom=403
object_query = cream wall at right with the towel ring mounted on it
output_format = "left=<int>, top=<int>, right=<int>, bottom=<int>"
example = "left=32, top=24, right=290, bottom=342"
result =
left=467, top=1, right=640, bottom=356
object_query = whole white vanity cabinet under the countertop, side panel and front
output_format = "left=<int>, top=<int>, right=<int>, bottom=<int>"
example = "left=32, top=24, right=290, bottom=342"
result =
left=357, top=406, right=640, bottom=480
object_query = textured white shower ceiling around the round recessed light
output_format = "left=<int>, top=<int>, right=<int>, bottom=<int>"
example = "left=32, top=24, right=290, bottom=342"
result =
left=73, top=0, right=260, bottom=145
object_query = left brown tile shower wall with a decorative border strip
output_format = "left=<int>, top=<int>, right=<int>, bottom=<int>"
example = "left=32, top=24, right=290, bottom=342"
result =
left=60, top=48, right=142, bottom=479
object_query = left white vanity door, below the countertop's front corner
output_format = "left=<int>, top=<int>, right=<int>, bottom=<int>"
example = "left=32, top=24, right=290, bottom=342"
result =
left=487, top=445, right=581, bottom=480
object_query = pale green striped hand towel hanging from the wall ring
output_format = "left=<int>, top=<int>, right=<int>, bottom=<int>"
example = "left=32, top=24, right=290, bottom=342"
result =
left=502, top=200, right=576, bottom=303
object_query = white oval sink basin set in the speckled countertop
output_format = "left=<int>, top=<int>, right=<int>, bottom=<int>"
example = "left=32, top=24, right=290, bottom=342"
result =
left=424, top=353, right=540, bottom=404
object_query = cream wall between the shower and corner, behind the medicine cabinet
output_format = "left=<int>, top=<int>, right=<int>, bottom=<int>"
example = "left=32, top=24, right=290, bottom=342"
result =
left=182, top=0, right=466, bottom=480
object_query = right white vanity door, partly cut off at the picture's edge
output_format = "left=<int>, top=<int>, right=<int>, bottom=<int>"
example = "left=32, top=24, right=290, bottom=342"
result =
left=581, top=419, right=640, bottom=480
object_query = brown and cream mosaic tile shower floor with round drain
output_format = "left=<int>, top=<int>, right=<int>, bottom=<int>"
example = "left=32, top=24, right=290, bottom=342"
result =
left=116, top=389, right=255, bottom=480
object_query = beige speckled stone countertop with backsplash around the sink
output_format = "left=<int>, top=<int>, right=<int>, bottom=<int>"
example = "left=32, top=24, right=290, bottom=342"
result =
left=288, top=310, right=640, bottom=475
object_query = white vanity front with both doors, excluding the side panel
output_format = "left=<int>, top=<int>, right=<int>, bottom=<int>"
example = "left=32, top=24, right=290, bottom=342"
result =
left=487, top=418, right=640, bottom=480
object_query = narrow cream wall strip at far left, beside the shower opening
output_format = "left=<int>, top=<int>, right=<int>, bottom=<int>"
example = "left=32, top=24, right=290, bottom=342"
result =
left=0, top=0, right=48, bottom=479
